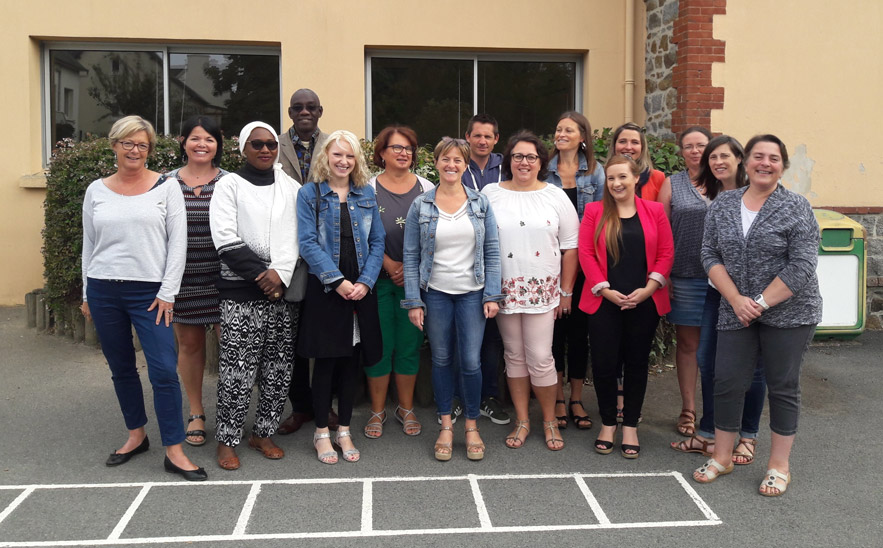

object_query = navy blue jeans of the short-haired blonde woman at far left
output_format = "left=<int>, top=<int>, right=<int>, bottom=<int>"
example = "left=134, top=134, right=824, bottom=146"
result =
left=86, top=278, right=184, bottom=446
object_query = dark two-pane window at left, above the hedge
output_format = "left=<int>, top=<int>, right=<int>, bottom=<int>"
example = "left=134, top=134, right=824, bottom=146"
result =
left=49, top=49, right=280, bottom=146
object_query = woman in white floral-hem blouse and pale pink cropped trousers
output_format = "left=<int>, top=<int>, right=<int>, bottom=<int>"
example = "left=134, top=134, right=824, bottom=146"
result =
left=482, top=132, right=579, bottom=451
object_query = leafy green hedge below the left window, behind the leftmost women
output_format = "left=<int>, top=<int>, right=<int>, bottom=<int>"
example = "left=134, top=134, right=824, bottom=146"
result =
left=43, top=137, right=242, bottom=321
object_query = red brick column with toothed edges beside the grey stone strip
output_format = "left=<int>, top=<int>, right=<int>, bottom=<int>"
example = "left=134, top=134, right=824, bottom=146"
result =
left=671, top=0, right=727, bottom=133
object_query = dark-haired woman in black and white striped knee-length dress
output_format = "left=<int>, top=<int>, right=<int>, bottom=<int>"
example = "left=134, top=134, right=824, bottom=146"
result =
left=169, top=116, right=227, bottom=445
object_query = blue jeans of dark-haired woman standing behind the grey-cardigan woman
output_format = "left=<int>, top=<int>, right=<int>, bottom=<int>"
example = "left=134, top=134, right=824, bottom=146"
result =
left=696, top=286, right=766, bottom=439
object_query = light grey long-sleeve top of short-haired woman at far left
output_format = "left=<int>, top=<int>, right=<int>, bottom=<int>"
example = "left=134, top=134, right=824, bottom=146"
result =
left=83, top=177, right=187, bottom=302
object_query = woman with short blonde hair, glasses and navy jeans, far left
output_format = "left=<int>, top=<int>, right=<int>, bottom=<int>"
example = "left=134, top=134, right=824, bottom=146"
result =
left=81, top=116, right=207, bottom=481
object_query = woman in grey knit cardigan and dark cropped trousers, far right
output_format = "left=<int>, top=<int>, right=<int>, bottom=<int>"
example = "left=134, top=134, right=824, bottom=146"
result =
left=693, top=135, right=822, bottom=497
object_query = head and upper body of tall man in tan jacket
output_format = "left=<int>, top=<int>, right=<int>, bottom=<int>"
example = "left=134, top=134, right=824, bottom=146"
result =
left=279, top=89, right=328, bottom=184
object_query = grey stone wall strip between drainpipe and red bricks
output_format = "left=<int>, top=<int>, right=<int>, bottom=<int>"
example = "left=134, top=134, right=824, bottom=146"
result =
left=644, top=0, right=679, bottom=139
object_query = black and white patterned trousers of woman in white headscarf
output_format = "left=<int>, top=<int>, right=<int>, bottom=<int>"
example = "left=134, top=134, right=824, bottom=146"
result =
left=215, top=299, right=298, bottom=447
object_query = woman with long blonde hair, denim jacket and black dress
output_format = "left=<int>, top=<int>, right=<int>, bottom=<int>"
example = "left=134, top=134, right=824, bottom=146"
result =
left=297, top=130, right=385, bottom=464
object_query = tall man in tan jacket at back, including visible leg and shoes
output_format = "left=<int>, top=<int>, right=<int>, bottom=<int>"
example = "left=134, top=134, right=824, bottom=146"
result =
left=277, top=89, right=337, bottom=435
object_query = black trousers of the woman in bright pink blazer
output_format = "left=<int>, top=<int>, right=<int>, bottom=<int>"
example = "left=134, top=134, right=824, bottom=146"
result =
left=589, top=298, right=659, bottom=427
